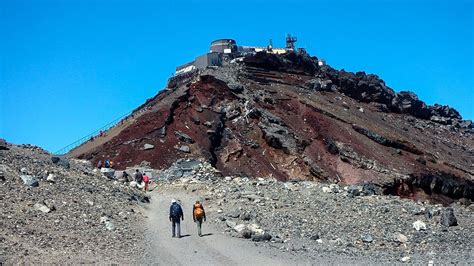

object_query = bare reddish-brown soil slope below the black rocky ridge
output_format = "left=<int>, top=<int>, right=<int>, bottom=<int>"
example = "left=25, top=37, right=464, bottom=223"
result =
left=74, top=59, right=474, bottom=203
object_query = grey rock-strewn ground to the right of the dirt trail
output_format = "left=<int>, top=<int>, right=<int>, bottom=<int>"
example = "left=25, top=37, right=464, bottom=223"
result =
left=157, top=160, right=474, bottom=265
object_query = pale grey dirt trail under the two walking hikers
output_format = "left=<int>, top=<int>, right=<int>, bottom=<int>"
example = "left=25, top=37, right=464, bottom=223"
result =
left=143, top=190, right=311, bottom=265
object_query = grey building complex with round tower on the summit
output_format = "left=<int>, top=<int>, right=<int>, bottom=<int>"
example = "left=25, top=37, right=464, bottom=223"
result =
left=175, top=34, right=306, bottom=76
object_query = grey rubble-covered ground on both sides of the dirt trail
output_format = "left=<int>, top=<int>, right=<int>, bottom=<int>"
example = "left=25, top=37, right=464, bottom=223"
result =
left=0, top=141, right=474, bottom=264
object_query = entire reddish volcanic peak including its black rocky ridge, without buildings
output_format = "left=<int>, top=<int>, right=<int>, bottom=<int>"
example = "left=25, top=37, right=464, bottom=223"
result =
left=71, top=53, right=474, bottom=203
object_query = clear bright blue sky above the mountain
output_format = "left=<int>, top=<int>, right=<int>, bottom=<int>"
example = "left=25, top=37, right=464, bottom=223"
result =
left=0, top=0, right=474, bottom=152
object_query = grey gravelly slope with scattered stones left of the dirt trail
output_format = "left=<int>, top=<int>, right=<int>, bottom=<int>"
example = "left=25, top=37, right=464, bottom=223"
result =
left=0, top=142, right=147, bottom=264
